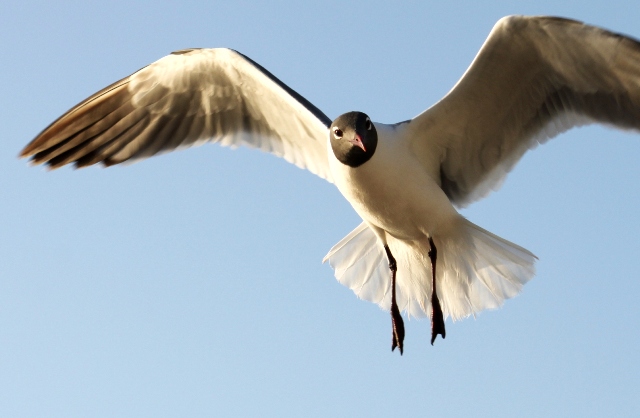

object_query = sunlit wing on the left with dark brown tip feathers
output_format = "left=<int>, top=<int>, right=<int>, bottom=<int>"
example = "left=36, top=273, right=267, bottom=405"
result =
left=21, top=49, right=332, bottom=181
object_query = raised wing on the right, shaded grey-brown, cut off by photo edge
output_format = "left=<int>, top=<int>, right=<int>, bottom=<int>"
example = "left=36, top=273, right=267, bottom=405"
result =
left=408, top=16, right=640, bottom=207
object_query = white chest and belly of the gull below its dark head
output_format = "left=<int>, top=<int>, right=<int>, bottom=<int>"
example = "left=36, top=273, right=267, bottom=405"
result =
left=329, top=125, right=457, bottom=239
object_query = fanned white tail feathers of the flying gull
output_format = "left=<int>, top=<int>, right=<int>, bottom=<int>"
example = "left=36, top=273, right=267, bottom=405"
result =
left=323, top=218, right=537, bottom=320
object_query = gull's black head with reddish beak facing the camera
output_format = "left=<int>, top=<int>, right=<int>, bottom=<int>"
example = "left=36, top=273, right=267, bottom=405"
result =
left=329, top=112, right=378, bottom=167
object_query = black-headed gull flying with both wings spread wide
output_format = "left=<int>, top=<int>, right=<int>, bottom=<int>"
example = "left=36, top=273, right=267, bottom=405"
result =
left=20, top=16, right=640, bottom=354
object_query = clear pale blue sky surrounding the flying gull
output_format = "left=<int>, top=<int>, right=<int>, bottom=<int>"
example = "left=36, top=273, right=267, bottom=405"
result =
left=0, top=0, right=640, bottom=417
